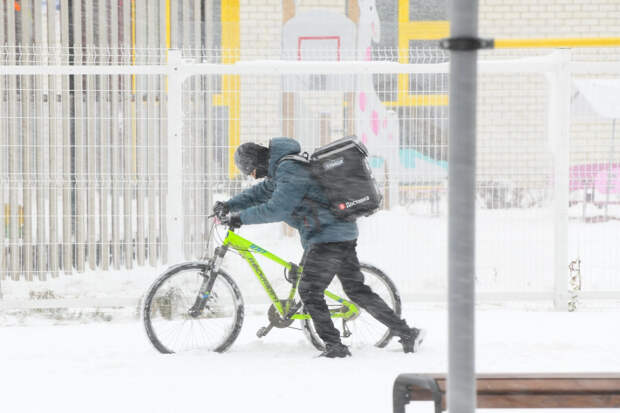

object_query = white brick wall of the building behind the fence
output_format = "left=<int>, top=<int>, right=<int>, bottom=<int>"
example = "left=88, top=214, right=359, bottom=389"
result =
left=235, top=0, right=620, bottom=171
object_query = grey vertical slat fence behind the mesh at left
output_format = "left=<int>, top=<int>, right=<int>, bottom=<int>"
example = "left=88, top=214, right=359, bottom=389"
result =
left=0, top=0, right=200, bottom=280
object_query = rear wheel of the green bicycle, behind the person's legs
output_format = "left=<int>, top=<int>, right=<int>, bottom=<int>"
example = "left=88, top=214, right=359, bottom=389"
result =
left=302, top=264, right=401, bottom=350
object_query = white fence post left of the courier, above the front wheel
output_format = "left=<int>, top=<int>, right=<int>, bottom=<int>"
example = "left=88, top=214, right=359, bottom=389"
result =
left=162, top=50, right=186, bottom=264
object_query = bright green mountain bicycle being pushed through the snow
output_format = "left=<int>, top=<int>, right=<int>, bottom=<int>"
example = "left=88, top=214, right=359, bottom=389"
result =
left=142, top=217, right=401, bottom=353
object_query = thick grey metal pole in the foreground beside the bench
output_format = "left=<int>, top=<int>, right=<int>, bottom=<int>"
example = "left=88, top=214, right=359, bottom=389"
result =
left=447, top=0, right=478, bottom=413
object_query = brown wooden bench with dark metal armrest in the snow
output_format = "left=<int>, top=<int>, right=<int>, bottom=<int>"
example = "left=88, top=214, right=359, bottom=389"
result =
left=393, top=373, right=620, bottom=413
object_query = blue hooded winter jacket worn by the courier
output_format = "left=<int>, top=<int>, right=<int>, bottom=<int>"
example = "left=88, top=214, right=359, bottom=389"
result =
left=227, top=138, right=358, bottom=249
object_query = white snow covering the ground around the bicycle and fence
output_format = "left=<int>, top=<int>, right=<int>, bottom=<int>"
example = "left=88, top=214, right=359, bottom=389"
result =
left=0, top=209, right=620, bottom=413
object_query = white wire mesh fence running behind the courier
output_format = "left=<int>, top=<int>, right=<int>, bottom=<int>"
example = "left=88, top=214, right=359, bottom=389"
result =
left=0, top=1, right=620, bottom=306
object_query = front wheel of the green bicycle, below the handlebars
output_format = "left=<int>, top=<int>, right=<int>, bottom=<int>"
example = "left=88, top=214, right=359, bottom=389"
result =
left=143, top=263, right=243, bottom=353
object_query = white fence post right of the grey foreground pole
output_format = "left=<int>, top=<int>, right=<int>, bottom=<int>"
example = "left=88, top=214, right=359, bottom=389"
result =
left=549, top=49, right=571, bottom=311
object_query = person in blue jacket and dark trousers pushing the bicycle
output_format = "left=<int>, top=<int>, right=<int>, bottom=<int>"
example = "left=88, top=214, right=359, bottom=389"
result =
left=213, top=138, right=424, bottom=358
